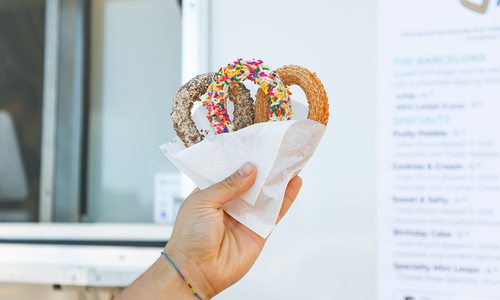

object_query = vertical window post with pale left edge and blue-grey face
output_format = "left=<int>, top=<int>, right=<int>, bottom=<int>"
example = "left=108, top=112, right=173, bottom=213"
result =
left=39, top=0, right=88, bottom=222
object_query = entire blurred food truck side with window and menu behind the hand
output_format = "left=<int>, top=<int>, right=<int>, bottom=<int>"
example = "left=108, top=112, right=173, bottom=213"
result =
left=0, top=0, right=500, bottom=300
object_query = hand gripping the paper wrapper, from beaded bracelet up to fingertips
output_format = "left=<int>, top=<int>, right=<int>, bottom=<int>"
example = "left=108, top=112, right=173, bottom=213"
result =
left=165, top=163, right=302, bottom=299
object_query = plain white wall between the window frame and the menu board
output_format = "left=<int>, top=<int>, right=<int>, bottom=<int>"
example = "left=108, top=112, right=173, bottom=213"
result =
left=212, top=0, right=376, bottom=300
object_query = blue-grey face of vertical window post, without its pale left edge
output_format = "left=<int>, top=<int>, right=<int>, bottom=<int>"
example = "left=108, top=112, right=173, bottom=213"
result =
left=52, top=0, right=88, bottom=222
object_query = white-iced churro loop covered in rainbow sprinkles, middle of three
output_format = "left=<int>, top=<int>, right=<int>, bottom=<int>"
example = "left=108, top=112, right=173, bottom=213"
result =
left=203, top=58, right=292, bottom=134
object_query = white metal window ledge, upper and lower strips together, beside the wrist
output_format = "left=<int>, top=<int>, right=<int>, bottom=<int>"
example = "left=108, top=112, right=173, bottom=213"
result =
left=0, top=223, right=172, bottom=287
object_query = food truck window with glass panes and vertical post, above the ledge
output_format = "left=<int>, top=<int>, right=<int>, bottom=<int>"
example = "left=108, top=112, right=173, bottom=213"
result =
left=0, top=0, right=182, bottom=224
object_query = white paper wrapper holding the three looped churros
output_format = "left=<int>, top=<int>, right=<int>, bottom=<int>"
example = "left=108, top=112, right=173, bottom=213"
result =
left=160, top=104, right=326, bottom=238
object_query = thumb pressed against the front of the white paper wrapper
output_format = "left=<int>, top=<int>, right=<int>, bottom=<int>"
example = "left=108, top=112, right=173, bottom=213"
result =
left=196, top=163, right=257, bottom=208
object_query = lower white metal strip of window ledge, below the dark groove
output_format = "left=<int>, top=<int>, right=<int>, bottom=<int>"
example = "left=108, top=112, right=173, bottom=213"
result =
left=0, top=245, right=161, bottom=287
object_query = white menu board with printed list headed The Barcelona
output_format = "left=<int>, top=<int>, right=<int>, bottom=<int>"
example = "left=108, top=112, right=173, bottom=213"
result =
left=377, top=0, right=500, bottom=300
